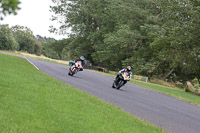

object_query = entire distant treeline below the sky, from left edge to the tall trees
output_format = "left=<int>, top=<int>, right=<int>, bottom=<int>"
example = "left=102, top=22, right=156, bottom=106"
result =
left=0, top=24, right=61, bottom=59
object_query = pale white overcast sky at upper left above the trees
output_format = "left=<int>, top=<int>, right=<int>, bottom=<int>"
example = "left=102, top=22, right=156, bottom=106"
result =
left=0, top=0, right=67, bottom=40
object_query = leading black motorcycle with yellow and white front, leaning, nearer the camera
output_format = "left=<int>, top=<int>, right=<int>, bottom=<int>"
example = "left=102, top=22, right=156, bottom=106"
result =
left=112, top=72, right=130, bottom=89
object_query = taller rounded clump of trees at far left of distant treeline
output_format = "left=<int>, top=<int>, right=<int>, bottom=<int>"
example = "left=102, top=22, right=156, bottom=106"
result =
left=0, top=25, right=42, bottom=55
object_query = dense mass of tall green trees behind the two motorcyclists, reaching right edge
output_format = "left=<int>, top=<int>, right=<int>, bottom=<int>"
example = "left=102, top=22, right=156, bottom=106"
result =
left=49, top=0, right=200, bottom=80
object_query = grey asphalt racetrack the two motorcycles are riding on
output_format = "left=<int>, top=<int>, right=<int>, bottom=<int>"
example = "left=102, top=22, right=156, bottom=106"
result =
left=1, top=53, right=200, bottom=133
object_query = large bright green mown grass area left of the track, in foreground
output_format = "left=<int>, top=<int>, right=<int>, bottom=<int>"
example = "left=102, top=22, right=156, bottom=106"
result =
left=0, top=54, right=164, bottom=133
